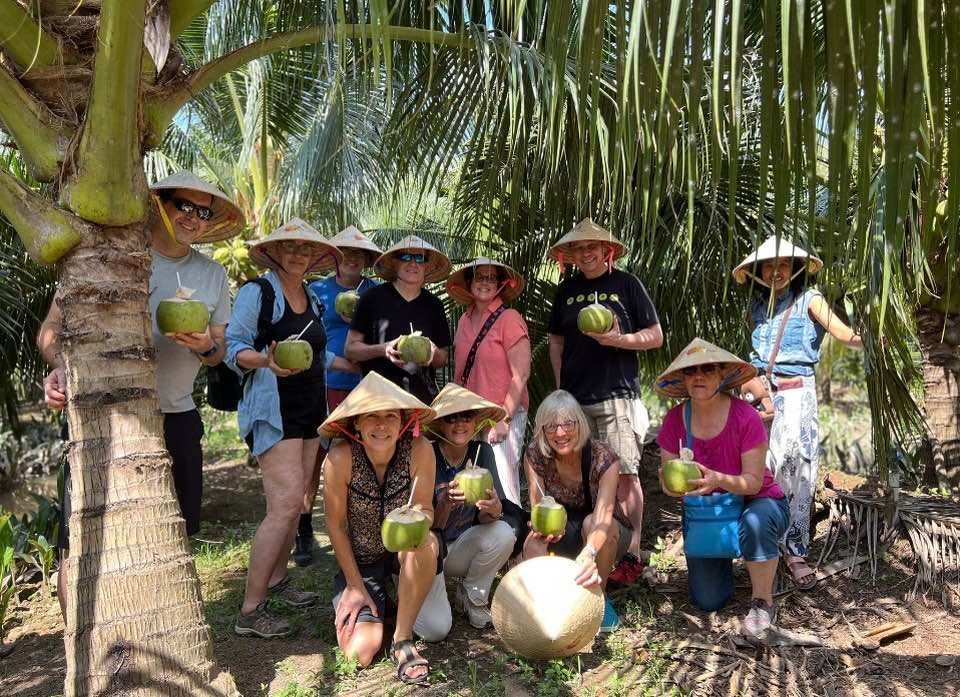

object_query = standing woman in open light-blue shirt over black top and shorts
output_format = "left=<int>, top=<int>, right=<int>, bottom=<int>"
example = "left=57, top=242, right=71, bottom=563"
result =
left=225, top=218, right=350, bottom=638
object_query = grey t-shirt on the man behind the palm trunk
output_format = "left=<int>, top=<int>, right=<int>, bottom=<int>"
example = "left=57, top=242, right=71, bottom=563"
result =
left=150, top=249, right=230, bottom=414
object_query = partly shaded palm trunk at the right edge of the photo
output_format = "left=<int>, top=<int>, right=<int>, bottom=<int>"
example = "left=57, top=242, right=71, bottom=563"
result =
left=917, top=308, right=960, bottom=492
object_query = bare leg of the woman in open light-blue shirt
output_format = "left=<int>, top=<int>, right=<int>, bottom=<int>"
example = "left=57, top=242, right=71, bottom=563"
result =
left=240, top=439, right=304, bottom=614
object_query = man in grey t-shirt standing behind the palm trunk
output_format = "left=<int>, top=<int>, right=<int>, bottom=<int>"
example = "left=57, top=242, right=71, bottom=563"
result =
left=37, top=172, right=244, bottom=612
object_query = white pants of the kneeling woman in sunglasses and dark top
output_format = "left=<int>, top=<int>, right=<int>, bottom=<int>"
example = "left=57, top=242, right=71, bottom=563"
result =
left=413, top=520, right=516, bottom=641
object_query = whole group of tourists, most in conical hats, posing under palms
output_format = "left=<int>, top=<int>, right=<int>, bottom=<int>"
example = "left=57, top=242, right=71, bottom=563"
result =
left=38, top=172, right=859, bottom=683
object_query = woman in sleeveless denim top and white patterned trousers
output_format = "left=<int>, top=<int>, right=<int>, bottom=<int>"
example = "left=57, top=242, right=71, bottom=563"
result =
left=733, top=236, right=863, bottom=590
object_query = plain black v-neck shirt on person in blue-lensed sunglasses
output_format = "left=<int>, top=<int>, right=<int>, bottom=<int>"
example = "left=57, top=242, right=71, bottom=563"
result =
left=350, top=283, right=452, bottom=404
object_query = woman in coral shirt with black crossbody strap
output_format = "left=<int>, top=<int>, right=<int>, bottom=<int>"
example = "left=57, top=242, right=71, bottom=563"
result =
left=447, top=257, right=530, bottom=506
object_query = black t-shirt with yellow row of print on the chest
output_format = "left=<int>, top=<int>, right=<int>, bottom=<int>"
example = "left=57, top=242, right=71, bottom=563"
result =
left=550, top=269, right=660, bottom=404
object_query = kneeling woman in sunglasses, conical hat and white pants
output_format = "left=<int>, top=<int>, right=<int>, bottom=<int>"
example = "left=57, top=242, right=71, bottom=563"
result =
left=430, top=382, right=524, bottom=629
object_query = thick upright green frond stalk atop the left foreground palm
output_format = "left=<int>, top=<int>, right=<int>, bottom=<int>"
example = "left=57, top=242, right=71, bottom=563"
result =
left=61, top=0, right=147, bottom=226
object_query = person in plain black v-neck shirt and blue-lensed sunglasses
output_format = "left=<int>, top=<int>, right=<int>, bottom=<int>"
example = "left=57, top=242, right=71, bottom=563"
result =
left=345, top=235, right=452, bottom=404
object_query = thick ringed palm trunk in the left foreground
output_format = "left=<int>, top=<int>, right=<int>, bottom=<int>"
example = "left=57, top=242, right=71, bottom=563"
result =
left=59, top=219, right=236, bottom=697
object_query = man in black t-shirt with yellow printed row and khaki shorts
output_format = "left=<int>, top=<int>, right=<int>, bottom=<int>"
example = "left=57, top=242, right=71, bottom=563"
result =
left=550, top=218, right=663, bottom=585
